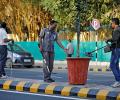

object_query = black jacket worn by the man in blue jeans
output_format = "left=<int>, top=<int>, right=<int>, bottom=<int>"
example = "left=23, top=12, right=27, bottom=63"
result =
left=107, top=27, right=120, bottom=49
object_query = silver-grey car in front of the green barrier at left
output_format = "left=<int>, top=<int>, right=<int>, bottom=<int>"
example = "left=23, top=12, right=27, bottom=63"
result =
left=6, top=43, right=34, bottom=67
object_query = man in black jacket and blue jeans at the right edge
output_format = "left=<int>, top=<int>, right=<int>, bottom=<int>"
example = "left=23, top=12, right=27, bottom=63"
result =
left=107, top=18, right=120, bottom=87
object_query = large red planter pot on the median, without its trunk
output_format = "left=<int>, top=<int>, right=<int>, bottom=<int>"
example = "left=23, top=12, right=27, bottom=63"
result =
left=67, top=58, right=90, bottom=85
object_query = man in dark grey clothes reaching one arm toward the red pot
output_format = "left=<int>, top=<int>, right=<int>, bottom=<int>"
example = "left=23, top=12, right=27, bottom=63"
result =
left=39, top=20, right=66, bottom=82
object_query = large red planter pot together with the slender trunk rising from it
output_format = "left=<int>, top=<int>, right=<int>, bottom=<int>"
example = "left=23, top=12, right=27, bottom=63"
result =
left=67, top=0, right=90, bottom=85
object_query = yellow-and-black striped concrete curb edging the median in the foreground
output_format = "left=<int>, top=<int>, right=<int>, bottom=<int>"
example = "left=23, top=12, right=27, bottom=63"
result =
left=0, top=80, right=120, bottom=100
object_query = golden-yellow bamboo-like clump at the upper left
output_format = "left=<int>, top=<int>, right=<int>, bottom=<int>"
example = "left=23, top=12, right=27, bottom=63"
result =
left=0, top=0, right=52, bottom=41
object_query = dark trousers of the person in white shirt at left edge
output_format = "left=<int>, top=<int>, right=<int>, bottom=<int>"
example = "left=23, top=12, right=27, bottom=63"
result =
left=0, top=45, right=7, bottom=77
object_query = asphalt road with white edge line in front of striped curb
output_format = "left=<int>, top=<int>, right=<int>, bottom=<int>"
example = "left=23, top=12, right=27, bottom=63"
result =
left=0, top=90, right=90, bottom=100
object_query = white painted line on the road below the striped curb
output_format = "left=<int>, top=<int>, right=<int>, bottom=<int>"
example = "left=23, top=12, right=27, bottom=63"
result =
left=0, top=90, right=89, bottom=100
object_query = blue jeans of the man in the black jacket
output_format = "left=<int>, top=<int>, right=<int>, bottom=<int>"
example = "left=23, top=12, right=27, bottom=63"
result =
left=110, top=48, right=120, bottom=82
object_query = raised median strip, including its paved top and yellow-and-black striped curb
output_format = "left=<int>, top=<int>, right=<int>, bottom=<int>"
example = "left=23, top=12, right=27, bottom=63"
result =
left=0, top=77, right=120, bottom=100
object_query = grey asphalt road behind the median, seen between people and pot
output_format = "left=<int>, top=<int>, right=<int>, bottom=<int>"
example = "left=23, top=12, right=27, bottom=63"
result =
left=6, top=68, right=115, bottom=86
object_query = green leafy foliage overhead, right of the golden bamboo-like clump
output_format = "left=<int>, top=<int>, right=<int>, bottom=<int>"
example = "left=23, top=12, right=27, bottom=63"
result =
left=26, top=0, right=120, bottom=30
